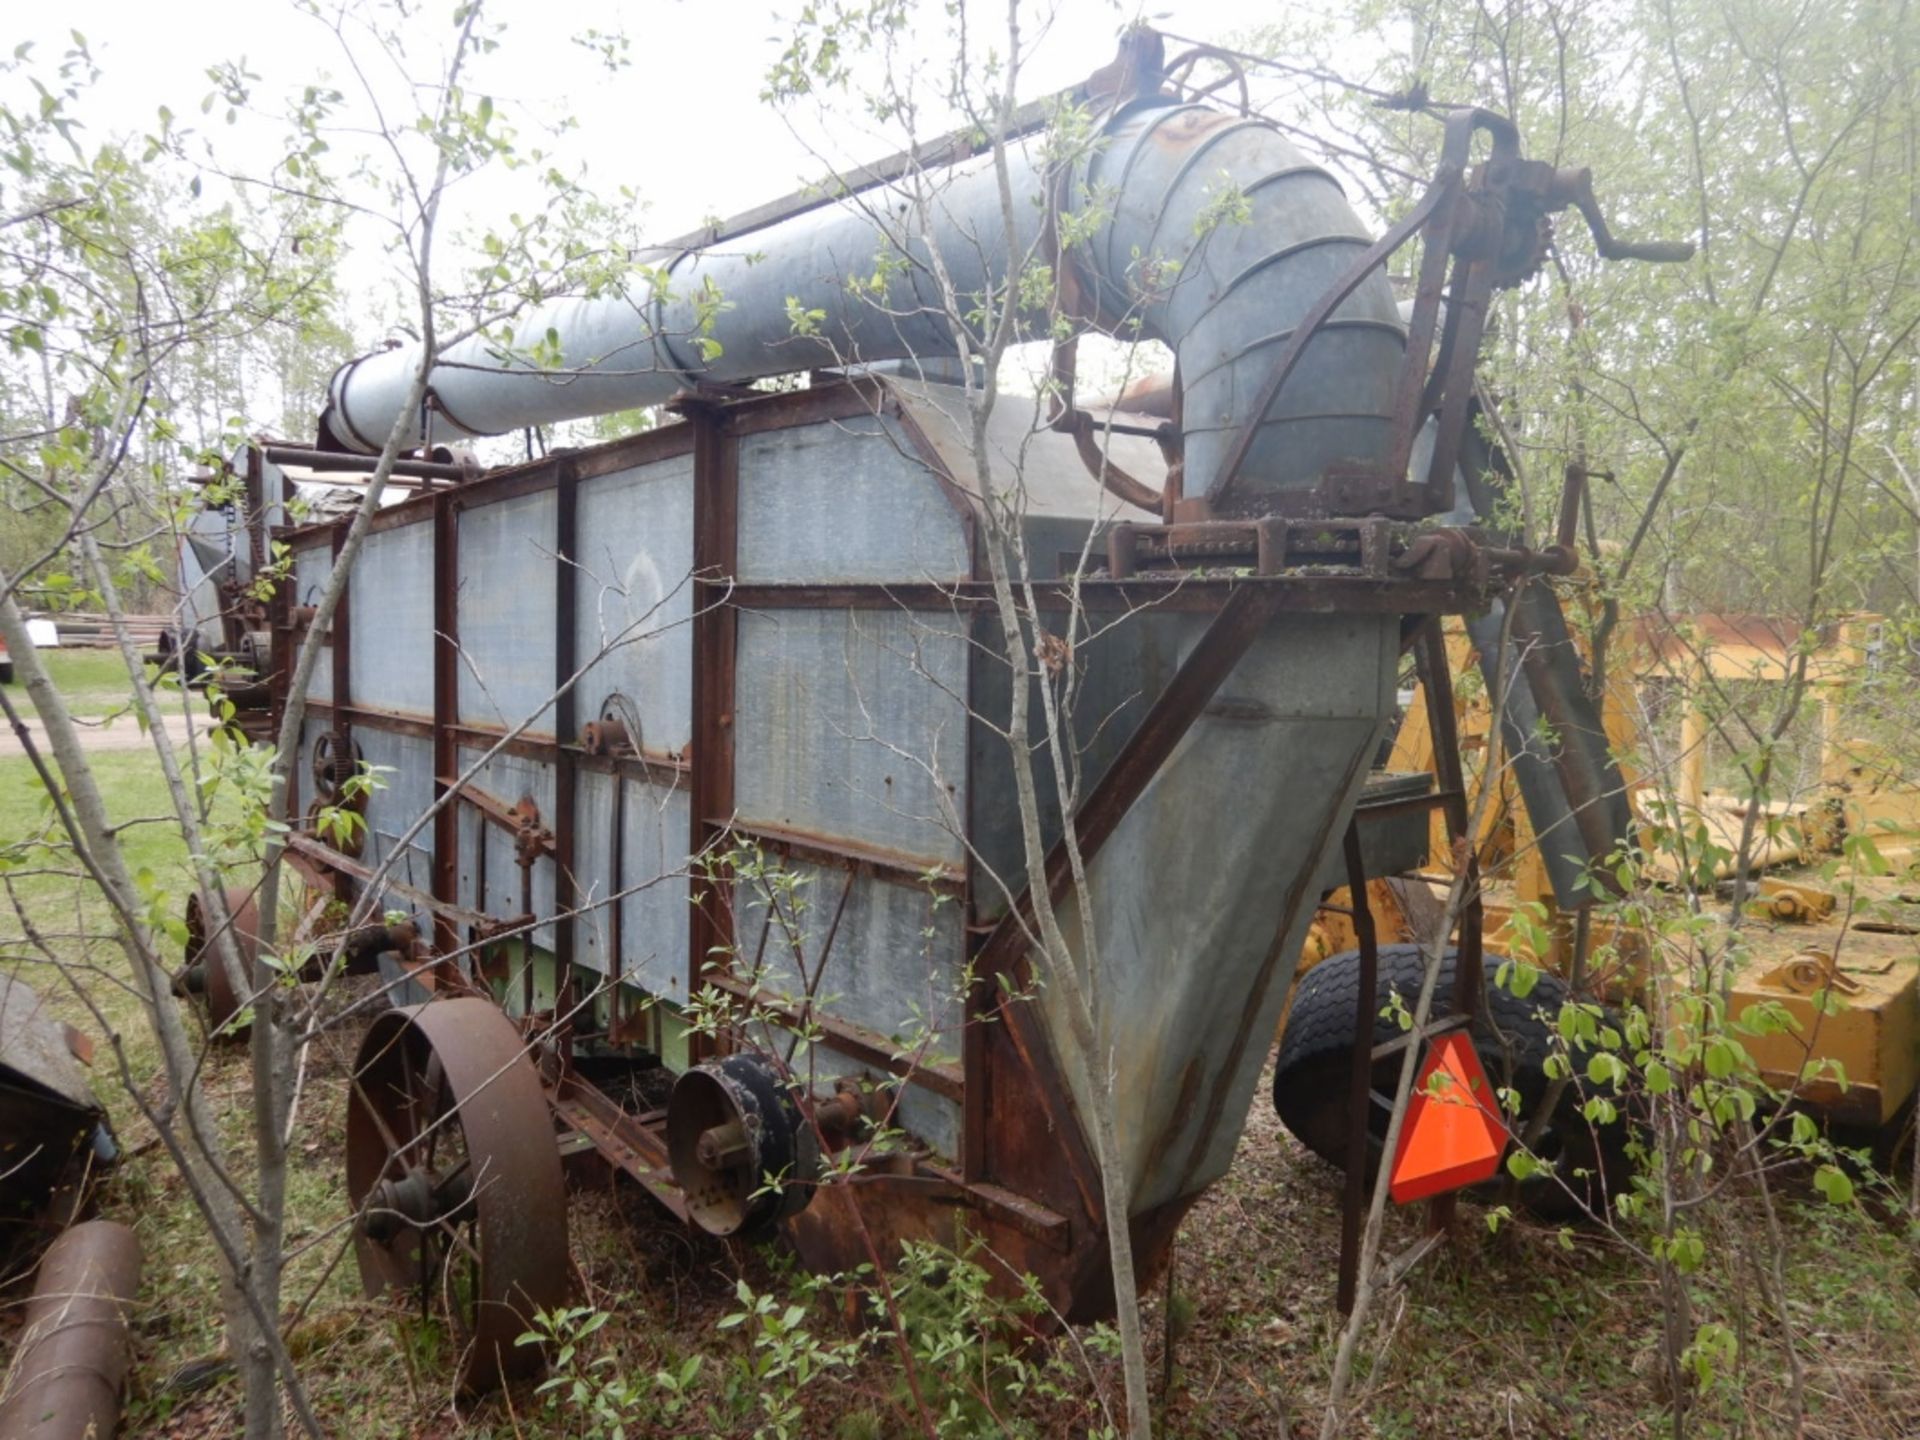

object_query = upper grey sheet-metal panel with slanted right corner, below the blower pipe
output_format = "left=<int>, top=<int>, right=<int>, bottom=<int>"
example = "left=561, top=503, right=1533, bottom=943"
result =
left=739, top=417, right=972, bottom=584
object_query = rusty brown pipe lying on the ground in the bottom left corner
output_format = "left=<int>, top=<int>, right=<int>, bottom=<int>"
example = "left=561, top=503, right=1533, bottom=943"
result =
left=0, top=1219, right=140, bottom=1440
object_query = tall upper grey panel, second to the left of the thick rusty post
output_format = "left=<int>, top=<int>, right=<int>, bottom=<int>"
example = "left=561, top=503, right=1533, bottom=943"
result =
left=456, top=490, right=557, bottom=735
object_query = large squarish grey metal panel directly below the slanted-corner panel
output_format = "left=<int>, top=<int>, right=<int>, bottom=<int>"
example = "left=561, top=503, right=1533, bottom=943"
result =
left=733, top=611, right=968, bottom=868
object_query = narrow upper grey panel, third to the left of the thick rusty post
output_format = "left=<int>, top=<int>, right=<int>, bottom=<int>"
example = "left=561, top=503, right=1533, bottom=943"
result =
left=348, top=520, right=434, bottom=716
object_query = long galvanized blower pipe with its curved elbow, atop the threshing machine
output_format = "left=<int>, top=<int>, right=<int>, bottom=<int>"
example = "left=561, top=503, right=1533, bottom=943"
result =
left=321, top=96, right=1404, bottom=511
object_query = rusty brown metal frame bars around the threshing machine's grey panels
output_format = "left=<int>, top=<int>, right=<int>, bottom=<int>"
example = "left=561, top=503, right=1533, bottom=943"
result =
left=266, top=366, right=1524, bottom=1305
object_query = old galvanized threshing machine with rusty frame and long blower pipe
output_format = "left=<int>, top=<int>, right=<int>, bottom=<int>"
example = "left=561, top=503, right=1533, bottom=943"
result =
left=177, top=31, right=1684, bottom=1382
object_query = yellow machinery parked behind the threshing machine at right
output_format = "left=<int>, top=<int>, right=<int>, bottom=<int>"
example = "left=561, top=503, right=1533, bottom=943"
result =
left=1300, top=616, right=1920, bottom=1129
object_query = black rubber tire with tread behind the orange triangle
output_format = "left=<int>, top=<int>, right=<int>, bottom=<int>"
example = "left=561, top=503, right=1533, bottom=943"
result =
left=1273, top=945, right=1628, bottom=1221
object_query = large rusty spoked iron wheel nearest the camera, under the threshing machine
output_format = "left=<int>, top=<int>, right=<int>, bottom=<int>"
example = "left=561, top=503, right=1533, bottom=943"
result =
left=348, top=996, right=572, bottom=1390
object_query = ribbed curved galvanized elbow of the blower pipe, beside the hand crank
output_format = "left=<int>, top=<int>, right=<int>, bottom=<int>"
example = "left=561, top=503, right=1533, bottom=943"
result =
left=1073, top=102, right=1405, bottom=511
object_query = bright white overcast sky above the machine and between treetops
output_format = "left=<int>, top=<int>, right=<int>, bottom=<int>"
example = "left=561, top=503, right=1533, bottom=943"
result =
left=8, top=0, right=1397, bottom=403
